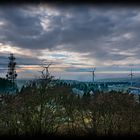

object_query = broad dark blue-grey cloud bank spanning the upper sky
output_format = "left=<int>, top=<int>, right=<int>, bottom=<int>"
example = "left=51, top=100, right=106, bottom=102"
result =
left=0, top=6, right=140, bottom=61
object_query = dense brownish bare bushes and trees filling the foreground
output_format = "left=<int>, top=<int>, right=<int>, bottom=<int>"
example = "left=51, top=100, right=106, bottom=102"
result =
left=0, top=78, right=140, bottom=136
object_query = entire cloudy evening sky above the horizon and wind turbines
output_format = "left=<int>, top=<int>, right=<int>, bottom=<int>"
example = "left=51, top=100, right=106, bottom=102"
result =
left=0, top=4, right=140, bottom=81
